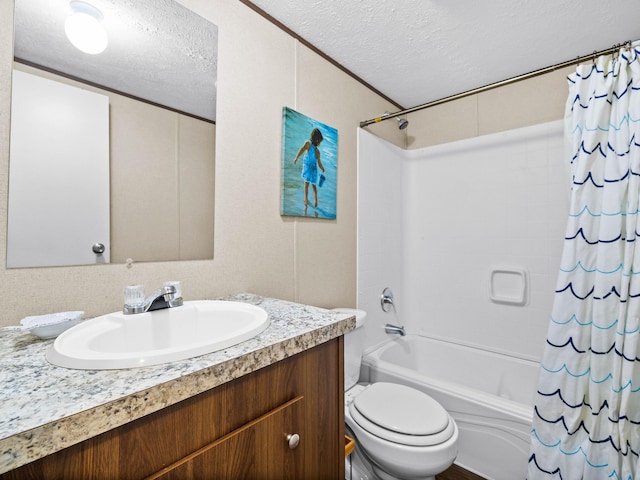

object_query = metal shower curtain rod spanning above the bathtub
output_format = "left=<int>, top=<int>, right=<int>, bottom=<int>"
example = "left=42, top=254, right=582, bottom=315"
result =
left=360, top=40, right=632, bottom=128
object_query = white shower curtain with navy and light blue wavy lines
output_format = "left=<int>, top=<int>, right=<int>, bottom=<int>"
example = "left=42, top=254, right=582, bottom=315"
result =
left=528, top=44, right=640, bottom=480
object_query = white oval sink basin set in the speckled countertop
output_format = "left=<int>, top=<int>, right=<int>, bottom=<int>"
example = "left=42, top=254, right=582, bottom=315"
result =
left=47, top=300, right=269, bottom=370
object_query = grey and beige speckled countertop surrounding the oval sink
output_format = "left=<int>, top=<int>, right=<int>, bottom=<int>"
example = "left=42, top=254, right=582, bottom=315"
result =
left=0, top=294, right=355, bottom=473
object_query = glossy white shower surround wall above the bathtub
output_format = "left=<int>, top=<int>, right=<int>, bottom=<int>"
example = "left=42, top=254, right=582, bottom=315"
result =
left=358, top=121, right=570, bottom=361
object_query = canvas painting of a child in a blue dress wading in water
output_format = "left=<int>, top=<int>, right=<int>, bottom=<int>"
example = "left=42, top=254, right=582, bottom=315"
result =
left=280, top=107, right=338, bottom=219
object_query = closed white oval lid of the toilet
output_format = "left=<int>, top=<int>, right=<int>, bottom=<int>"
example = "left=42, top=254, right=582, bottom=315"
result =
left=352, top=382, right=449, bottom=436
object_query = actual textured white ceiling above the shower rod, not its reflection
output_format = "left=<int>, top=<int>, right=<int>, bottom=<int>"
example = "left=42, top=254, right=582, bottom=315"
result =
left=245, top=0, right=640, bottom=108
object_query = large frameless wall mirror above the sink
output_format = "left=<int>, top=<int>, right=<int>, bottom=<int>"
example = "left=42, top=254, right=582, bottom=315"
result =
left=7, top=0, right=218, bottom=268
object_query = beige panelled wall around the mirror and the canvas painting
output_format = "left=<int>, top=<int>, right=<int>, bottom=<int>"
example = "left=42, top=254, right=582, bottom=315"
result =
left=0, top=0, right=404, bottom=325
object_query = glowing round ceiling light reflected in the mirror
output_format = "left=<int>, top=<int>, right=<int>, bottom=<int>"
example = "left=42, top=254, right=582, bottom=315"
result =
left=64, top=0, right=109, bottom=55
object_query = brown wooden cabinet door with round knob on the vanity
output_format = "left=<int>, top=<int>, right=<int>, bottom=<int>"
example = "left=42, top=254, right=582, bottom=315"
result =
left=148, top=396, right=306, bottom=480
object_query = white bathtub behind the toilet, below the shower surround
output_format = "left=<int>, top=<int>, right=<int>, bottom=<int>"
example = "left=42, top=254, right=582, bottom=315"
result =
left=361, top=335, right=540, bottom=480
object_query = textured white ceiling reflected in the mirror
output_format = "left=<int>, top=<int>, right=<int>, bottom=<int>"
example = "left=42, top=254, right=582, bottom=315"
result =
left=14, top=0, right=218, bottom=120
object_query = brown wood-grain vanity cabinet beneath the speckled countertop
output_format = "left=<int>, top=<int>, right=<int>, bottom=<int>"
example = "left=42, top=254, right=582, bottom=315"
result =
left=0, top=337, right=344, bottom=480
